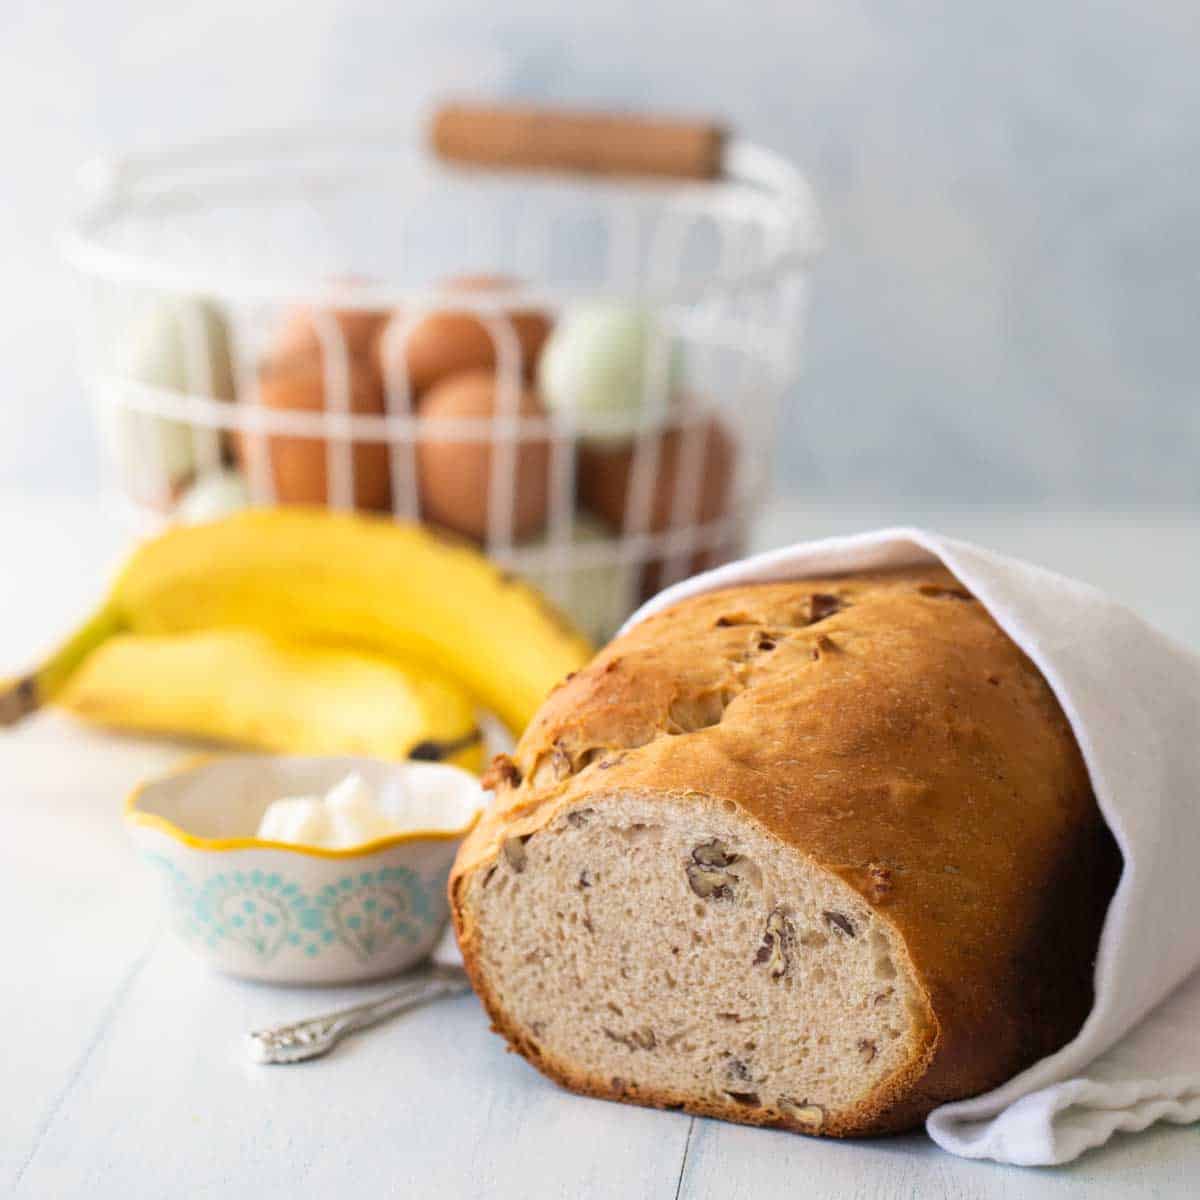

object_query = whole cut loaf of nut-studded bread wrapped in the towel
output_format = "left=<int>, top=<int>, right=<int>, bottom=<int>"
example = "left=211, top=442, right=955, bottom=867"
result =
left=450, top=568, right=1120, bottom=1135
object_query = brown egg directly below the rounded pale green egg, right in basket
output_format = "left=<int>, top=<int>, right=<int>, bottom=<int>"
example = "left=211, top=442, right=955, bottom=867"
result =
left=578, top=416, right=737, bottom=600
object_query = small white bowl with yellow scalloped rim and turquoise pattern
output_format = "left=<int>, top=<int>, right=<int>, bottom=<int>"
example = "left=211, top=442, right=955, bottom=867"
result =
left=125, top=755, right=485, bottom=984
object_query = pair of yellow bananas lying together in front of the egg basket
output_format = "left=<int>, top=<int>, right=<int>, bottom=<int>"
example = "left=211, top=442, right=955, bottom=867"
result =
left=0, top=508, right=590, bottom=768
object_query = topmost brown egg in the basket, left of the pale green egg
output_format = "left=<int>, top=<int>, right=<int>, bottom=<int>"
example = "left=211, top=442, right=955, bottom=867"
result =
left=379, top=275, right=551, bottom=396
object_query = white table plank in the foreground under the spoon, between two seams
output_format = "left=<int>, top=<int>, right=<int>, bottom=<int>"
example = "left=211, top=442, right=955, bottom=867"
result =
left=18, top=936, right=688, bottom=1198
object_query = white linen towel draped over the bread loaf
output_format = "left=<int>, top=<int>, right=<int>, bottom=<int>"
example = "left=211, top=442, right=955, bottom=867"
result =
left=625, top=529, right=1200, bottom=1165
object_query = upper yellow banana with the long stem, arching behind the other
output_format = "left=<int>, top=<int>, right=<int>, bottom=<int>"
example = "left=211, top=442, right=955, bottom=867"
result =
left=0, top=508, right=592, bottom=736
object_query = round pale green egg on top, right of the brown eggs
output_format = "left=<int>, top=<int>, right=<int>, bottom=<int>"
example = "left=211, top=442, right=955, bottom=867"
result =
left=538, top=304, right=680, bottom=444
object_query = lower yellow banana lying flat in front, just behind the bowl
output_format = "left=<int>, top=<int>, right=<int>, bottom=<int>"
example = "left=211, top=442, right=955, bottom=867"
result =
left=58, top=629, right=481, bottom=770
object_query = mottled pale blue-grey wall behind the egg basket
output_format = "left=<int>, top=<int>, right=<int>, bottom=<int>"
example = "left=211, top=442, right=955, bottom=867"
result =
left=0, top=0, right=1200, bottom=511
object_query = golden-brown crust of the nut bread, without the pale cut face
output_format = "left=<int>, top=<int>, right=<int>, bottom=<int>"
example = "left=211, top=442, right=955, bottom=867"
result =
left=449, top=568, right=1120, bottom=1136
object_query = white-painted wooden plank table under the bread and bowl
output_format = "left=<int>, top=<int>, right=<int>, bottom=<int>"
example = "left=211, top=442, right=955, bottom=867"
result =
left=0, top=496, right=1200, bottom=1200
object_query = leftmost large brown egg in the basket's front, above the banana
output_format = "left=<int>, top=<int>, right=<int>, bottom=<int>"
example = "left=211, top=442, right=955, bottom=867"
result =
left=235, top=353, right=391, bottom=509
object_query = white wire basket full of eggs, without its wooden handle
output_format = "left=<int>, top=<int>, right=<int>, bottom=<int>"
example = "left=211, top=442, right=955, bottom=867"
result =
left=68, top=108, right=815, bottom=638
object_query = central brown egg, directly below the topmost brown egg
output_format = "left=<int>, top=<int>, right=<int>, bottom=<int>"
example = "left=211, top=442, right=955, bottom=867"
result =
left=416, top=371, right=550, bottom=541
